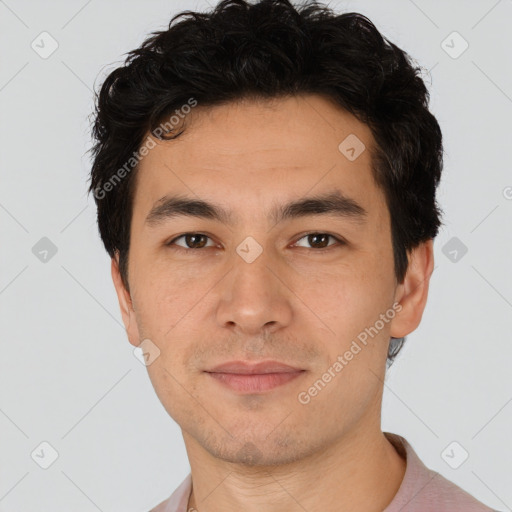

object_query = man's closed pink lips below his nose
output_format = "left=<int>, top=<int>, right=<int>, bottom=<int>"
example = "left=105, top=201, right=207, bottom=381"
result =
left=206, top=361, right=305, bottom=393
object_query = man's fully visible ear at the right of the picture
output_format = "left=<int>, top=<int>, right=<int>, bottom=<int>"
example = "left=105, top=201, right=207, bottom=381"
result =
left=390, top=239, right=434, bottom=338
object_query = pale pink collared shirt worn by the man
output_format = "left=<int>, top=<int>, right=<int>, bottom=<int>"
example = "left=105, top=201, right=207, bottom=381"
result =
left=150, top=432, right=493, bottom=512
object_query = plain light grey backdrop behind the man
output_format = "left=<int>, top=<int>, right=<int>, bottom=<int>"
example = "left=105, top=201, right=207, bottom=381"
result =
left=0, top=0, right=512, bottom=512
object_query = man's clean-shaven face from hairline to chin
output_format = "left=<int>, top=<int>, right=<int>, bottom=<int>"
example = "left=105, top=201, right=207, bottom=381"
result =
left=115, top=95, right=420, bottom=464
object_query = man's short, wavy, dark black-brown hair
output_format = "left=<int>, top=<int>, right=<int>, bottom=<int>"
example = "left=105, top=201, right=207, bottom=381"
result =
left=89, top=0, right=443, bottom=361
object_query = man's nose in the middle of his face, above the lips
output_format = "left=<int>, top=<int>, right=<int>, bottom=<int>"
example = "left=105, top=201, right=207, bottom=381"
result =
left=217, top=244, right=295, bottom=336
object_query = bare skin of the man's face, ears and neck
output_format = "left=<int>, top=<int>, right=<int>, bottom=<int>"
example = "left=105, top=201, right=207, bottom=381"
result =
left=112, top=95, right=434, bottom=512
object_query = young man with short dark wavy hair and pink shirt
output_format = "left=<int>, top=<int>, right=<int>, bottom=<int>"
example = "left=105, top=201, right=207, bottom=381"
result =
left=90, top=0, right=491, bottom=512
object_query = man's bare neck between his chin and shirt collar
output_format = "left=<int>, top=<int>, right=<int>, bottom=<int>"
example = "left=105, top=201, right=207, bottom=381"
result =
left=184, top=429, right=406, bottom=512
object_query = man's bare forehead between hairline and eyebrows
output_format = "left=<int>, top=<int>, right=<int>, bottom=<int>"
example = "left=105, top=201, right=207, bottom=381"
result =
left=134, top=95, right=382, bottom=224
